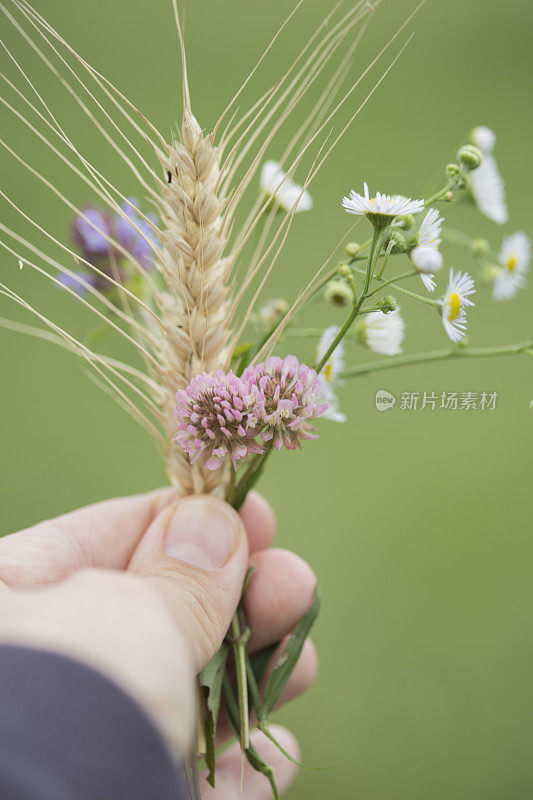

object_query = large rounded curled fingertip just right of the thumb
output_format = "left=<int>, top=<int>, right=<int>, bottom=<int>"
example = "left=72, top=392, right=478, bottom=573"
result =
left=244, top=549, right=316, bottom=652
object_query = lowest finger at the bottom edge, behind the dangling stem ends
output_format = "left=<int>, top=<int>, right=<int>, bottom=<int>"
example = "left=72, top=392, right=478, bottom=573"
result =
left=200, top=725, right=300, bottom=800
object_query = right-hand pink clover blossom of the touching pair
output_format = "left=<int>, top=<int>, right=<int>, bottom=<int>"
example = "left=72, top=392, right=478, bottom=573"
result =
left=242, top=356, right=328, bottom=451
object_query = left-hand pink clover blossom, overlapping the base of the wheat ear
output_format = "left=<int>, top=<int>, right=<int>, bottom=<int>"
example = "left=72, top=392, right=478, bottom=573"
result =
left=174, top=370, right=263, bottom=470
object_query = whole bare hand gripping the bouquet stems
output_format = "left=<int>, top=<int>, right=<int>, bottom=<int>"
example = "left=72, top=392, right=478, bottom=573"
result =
left=0, top=489, right=317, bottom=800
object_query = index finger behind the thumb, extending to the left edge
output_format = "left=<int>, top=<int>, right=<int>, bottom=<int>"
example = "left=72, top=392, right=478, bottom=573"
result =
left=0, top=489, right=175, bottom=589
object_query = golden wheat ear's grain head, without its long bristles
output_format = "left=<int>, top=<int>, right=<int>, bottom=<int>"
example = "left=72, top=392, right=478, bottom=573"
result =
left=156, top=107, right=229, bottom=494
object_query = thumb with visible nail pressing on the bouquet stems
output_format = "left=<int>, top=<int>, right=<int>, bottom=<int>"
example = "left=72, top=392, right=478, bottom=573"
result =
left=128, top=495, right=248, bottom=671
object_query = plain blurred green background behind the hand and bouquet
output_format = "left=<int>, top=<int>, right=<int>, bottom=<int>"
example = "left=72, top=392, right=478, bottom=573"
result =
left=0, top=0, right=533, bottom=800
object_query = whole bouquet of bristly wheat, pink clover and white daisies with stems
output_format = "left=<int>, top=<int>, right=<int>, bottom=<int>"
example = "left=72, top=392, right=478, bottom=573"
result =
left=0, top=0, right=533, bottom=797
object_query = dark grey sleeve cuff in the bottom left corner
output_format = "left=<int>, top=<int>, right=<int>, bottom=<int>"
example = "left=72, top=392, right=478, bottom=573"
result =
left=0, top=645, right=187, bottom=800
